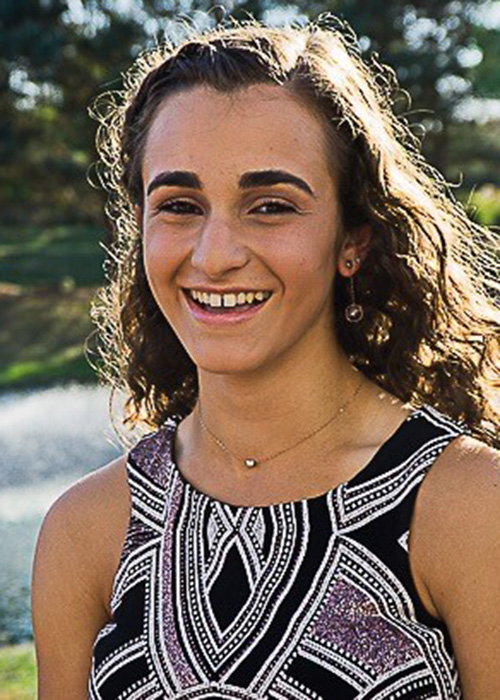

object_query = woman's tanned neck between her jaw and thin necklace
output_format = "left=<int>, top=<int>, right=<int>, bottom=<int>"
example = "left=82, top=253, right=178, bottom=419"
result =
left=190, top=340, right=372, bottom=473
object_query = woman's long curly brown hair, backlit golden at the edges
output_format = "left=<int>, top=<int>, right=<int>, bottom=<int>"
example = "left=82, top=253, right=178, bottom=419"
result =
left=87, top=13, right=500, bottom=447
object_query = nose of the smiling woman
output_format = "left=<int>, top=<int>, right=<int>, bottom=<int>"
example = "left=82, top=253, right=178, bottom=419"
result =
left=191, top=217, right=248, bottom=277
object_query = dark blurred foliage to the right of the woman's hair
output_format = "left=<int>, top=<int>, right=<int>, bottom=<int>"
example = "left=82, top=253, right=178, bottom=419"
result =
left=290, top=0, right=500, bottom=189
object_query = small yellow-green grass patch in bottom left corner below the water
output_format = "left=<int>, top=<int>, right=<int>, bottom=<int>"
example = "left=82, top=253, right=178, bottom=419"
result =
left=0, top=643, right=36, bottom=700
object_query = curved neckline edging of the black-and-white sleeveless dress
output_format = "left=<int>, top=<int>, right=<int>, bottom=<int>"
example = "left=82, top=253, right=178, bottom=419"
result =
left=163, top=404, right=425, bottom=512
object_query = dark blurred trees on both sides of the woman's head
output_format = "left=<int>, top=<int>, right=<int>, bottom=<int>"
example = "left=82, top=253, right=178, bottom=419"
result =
left=0, top=0, right=500, bottom=224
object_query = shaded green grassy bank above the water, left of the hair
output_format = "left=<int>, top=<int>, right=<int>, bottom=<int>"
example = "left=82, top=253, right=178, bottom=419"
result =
left=0, top=225, right=109, bottom=391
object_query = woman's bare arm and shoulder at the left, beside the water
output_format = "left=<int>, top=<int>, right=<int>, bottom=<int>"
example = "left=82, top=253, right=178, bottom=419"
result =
left=31, top=455, right=130, bottom=700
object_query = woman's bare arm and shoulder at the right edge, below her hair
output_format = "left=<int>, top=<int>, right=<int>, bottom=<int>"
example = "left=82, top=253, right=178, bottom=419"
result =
left=416, top=436, right=500, bottom=700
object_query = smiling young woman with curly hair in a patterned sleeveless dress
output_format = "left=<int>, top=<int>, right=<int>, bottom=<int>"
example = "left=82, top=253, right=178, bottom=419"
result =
left=33, top=15, right=500, bottom=700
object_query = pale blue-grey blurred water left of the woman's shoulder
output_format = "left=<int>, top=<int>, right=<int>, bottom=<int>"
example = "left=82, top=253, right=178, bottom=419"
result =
left=0, top=384, right=124, bottom=643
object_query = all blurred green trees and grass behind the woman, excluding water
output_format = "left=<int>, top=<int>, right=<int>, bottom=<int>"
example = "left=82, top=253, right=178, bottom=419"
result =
left=0, top=0, right=500, bottom=700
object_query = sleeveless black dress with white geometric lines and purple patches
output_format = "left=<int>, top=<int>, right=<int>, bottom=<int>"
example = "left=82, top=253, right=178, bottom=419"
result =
left=88, top=404, right=469, bottom=700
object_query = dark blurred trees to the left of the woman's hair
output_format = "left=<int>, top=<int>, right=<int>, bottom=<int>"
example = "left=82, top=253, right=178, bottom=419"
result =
left=0, top=0, right=143, bottom=223
